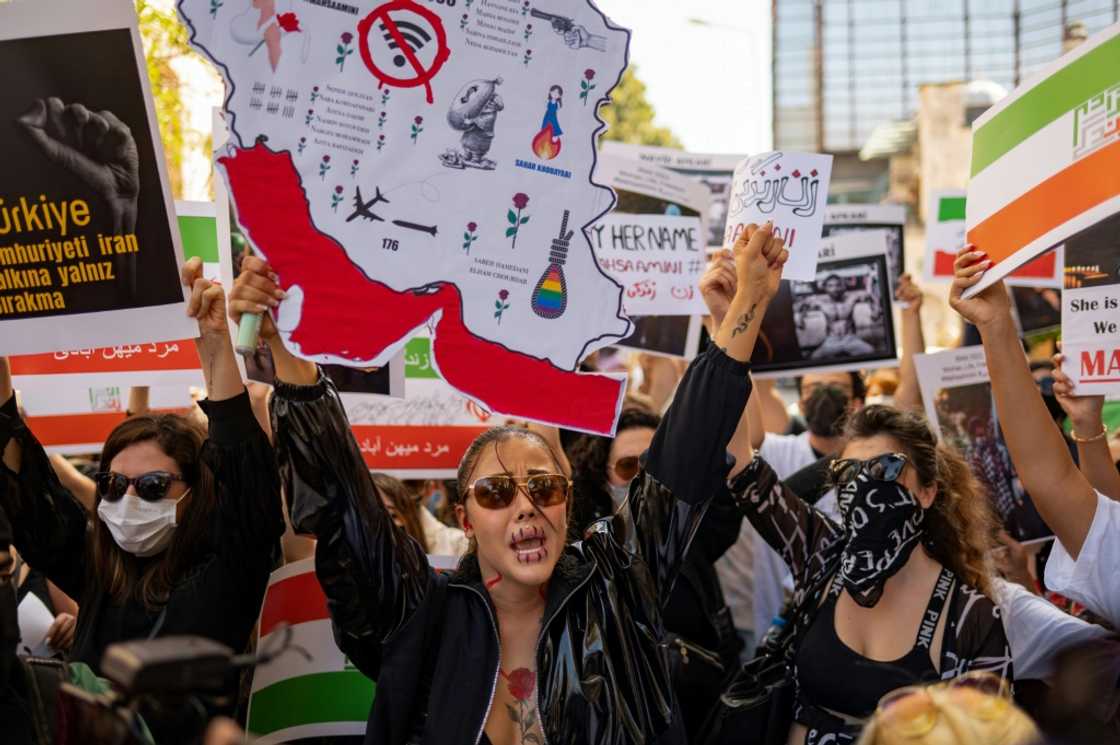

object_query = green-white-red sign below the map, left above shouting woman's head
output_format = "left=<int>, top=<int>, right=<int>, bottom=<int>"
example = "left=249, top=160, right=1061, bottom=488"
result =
left=342, top=336, right=490, bottom=478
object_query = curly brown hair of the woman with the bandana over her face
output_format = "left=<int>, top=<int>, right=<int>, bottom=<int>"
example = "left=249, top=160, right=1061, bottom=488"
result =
left=844, top=404, right=997, bottom=596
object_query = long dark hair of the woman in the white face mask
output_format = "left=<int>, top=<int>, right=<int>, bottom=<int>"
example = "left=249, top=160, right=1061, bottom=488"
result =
left=91, top=415, right=217, bottom=609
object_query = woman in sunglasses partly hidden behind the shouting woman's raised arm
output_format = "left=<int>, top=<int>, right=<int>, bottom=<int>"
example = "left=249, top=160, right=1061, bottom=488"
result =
left=569, top=408, right=743, bottom=742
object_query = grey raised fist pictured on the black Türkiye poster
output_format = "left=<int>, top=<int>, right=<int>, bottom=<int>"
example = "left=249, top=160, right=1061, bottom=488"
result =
left=18, top=97, right=140, bottom=235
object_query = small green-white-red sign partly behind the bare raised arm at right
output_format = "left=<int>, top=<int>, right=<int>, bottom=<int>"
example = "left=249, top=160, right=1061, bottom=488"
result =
left=922, top=189, right=1062, bottom=288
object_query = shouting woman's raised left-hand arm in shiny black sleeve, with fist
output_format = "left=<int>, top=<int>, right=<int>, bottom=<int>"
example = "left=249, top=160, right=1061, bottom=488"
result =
left=230, top=257, right=432, bottom=678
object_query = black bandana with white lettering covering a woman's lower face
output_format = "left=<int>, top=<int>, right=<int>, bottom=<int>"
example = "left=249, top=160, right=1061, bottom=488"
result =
left=838, top=473, right=925, bottom=608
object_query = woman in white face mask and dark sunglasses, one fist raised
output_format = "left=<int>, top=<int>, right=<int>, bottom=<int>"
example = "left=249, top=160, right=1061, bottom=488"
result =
left=0, top=259, right=283, bottom=681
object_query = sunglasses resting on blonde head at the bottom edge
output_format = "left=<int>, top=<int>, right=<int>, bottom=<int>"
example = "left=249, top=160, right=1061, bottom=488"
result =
left=877, top=671, right=1011, bottom=738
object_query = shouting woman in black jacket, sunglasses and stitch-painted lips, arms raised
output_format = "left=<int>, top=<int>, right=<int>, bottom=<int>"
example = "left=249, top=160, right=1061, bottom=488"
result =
left=231, top=227, right=788, bottom=745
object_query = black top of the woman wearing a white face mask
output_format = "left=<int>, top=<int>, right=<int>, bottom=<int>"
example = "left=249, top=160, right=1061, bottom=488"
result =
left=0, top=392, right=284, bottom=672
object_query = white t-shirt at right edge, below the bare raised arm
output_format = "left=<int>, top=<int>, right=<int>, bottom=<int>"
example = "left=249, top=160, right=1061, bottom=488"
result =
left=1046, top=492, right=1120, bottom=628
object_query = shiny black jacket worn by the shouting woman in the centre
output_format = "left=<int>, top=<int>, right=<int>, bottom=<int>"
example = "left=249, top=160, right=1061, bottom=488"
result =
left=272, top=347, right=749, bottom=745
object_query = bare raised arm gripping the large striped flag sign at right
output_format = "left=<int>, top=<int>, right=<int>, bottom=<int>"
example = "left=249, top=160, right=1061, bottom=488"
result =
left=949, top=245, right=1096, bottom=559
